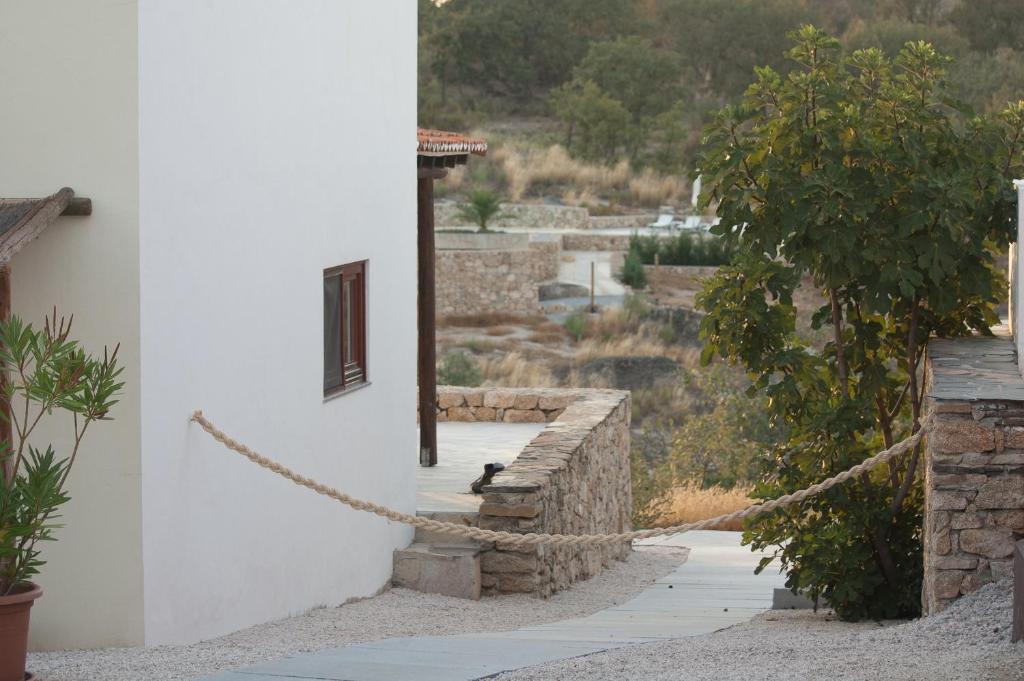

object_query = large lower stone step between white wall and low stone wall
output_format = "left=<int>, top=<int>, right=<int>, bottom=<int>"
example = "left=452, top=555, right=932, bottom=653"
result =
left=391, top=543, right=480, bottom=600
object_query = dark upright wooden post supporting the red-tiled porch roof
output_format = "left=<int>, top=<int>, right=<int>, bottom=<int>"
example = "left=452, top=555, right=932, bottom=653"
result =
left=416, top=177, right=437, bottom=466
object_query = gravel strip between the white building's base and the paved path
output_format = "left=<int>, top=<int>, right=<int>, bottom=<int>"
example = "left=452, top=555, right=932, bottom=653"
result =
left=29, top=547, right=687, bottom=681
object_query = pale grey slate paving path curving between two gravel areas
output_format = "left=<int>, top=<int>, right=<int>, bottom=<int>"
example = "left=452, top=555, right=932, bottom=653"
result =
left=195, top=531, right=784, bottom=681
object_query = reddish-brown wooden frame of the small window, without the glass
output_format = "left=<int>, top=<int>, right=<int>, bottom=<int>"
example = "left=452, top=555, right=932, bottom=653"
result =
left=324, top=260, right=370, bottom=398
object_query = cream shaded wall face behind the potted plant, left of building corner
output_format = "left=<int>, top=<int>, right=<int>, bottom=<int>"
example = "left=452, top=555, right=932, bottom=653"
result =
left=0, top=0, right=143, bottom=648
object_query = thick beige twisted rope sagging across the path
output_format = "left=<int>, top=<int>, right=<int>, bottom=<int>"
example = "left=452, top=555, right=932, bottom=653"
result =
left=191, top=411, right=932, bottom=547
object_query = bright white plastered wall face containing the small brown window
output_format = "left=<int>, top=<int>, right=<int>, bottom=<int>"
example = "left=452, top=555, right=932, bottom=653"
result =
left=138, top=0, right=417, bottom=644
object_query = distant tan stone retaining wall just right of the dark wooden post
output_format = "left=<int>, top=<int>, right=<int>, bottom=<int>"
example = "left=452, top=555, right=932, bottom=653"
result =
left=434, top=235, right=561, bottom=316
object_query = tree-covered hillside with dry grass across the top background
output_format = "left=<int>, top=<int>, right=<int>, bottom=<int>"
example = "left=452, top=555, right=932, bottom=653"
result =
left=419, top=0, right=1024, bottom=210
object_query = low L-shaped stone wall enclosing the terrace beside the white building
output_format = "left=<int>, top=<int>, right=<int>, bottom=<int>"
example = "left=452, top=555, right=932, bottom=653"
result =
left=437, top=387, right=632, bottom=597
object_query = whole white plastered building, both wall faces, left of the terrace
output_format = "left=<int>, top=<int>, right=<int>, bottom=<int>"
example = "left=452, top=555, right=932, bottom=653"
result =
left=0, top=0, right=417, bottom=648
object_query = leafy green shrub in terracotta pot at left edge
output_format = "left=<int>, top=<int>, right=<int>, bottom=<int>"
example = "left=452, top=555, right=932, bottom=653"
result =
left=0, top=310, right=124, bottom=681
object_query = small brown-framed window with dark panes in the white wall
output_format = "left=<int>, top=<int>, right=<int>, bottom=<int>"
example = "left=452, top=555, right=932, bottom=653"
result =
left=324, top=260, right=367, bottom=396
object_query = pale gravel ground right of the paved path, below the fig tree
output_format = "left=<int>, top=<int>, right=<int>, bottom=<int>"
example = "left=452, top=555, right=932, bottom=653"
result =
left=495, top=582, right=1024, bottom=681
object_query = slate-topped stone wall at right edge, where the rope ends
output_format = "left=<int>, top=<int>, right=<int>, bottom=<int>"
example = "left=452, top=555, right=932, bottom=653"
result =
left=923, top=337, right=1024, bottom=614
